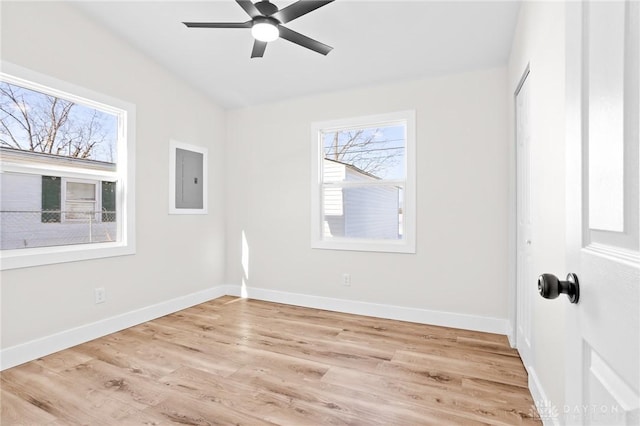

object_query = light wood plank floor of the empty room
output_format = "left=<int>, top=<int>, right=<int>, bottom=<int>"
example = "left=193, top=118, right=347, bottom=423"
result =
left=0, top=297, right=539, bottom=426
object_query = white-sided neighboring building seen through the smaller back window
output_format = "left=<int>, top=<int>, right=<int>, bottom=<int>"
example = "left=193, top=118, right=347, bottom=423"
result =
left=323, top=158, right=402, bottom=240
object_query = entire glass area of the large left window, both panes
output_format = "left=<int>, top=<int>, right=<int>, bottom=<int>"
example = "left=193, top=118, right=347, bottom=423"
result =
left=0, top=81, right=120, bottom=250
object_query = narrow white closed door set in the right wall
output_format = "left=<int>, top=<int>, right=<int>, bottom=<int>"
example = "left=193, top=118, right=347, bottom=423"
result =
left=516, top=68, right=537, bottom=371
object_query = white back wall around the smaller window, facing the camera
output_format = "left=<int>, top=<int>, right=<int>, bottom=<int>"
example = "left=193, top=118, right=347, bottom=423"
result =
left=227, top=69, right=508, bottom=320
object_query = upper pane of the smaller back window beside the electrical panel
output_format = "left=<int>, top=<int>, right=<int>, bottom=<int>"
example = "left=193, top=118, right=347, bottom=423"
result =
left=322, top=125, right=406, bottom=182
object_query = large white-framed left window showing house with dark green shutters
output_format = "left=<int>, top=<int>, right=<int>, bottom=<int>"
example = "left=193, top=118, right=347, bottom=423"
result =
left=0, top=62, right=135, bottom=269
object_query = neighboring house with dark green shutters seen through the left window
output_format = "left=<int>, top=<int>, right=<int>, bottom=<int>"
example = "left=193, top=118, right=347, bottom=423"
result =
left=0, top=148, right=117, bottom=250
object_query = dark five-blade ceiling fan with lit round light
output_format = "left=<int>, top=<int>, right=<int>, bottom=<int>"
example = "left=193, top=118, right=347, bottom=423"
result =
left=183, top=0, right=334, bottom=58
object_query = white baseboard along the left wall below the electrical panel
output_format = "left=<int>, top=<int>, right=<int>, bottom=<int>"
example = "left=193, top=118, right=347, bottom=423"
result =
left=0, top=286, right=234, bottom=371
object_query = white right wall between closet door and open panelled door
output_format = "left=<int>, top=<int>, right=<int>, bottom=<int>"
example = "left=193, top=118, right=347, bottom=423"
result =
left=508, top=2, right=570, bottom=409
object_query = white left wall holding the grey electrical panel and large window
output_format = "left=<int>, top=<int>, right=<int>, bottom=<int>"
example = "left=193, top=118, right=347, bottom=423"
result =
left=1, top=2, right=226, bottom=350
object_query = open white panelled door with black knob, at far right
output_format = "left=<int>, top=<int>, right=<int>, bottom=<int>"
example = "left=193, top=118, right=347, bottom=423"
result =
left=568, top=0, right=640, bottom=425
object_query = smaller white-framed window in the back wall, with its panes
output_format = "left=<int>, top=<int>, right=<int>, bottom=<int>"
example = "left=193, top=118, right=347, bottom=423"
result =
left=311, top=111, right=416, bottom=253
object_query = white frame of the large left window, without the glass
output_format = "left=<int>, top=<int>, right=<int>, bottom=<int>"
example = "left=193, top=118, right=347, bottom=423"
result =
left=0, top=61, right=136, bottom=270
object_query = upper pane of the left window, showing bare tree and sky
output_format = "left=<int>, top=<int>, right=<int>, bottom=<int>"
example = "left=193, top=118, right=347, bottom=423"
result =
left=0, top=82, right=118, bottom=163
